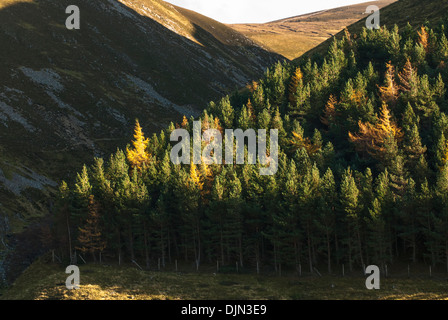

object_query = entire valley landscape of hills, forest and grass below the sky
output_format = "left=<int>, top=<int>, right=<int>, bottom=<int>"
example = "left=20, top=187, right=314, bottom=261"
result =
left=0, top=0, right=448, bottom=300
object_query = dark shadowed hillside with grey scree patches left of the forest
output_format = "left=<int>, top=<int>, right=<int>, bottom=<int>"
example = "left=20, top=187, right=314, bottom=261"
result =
left=0, top=0, right=279, bottom=284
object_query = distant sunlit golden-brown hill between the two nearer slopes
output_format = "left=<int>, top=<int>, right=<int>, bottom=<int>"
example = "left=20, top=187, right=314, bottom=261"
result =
left=230, top=0, right=396, bottom=60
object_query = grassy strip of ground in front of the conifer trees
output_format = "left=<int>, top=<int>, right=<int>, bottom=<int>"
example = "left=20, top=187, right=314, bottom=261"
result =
left=0, top=256, right=448, bottom=300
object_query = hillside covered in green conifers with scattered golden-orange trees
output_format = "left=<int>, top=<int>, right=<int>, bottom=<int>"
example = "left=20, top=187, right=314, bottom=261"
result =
left=22, top=0, right=448, bottom=298
